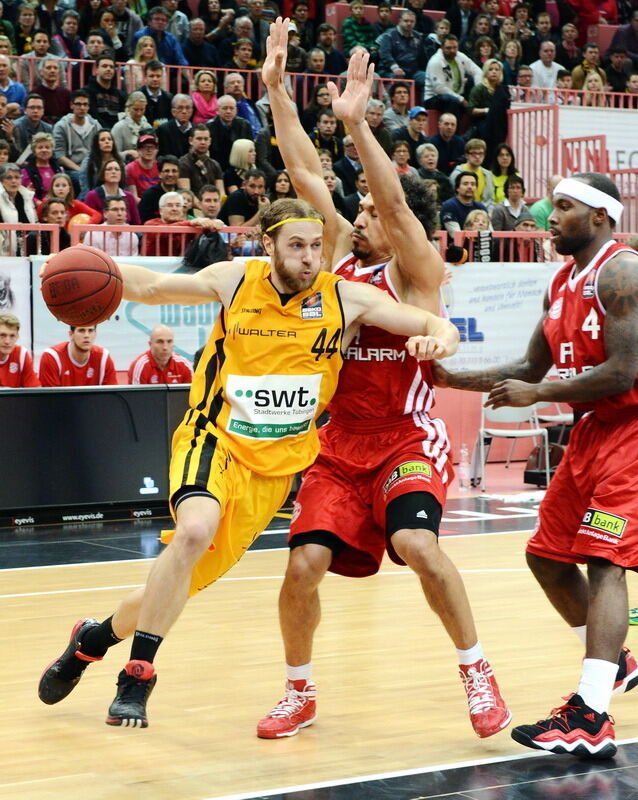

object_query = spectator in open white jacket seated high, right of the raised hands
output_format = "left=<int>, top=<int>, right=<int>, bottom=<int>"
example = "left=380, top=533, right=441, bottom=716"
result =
left=423, top=34, right=482, bottom=121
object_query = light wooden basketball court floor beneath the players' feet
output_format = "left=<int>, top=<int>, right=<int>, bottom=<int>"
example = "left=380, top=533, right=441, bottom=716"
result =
left=0, top=482, right=638, bottom=800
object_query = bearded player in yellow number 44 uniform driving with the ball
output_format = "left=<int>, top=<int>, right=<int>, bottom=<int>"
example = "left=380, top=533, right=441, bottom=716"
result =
left=39, top=199, right=458, bottom=728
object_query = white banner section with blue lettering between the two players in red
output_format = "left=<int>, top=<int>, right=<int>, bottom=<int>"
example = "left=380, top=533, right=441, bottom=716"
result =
left=443, top=263, right=560, bottom=370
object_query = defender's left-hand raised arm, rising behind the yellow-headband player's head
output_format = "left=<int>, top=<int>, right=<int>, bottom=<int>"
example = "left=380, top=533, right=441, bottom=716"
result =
left=261, top=17, right=352, bottom=262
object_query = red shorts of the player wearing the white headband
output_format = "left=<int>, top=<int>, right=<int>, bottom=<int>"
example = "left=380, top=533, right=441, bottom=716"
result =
left=527, top=414, right=638, bottom=569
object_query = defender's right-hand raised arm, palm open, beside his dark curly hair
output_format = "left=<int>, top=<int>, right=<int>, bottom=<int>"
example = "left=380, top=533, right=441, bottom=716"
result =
left=328, top=52, right=444, bottom=311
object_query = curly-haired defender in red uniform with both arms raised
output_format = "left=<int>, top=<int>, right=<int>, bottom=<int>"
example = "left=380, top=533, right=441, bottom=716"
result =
left=257, top=20, right=511, bottom=738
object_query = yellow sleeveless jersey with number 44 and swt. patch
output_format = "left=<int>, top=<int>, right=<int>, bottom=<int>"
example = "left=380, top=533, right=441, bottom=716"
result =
left=184, top=259, right=344, bottom=476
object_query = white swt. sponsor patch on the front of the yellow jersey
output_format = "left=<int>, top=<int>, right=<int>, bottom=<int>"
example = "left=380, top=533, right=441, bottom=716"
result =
left=226, top=374, right=322, bottom=440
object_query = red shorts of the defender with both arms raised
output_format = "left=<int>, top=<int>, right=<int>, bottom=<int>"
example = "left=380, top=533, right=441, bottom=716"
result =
left=290, top=419, right=454, bottom=577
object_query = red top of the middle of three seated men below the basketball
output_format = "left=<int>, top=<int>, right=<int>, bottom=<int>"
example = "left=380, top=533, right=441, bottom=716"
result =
left=40, top=342, right=117, bottom=386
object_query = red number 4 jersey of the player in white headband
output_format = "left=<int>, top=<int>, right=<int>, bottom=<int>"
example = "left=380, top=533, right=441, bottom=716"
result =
left=543, top=241, right=638, bottom=420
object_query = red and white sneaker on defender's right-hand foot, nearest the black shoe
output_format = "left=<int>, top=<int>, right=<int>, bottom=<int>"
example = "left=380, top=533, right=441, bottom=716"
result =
left=459, top=658, right=512, bottom=739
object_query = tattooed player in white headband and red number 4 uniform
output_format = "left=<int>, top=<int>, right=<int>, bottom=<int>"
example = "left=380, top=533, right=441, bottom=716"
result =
left=434, top=173, right=638, bottom=758
